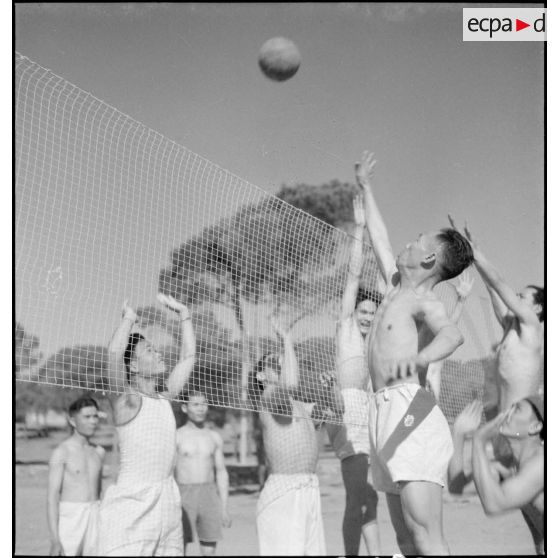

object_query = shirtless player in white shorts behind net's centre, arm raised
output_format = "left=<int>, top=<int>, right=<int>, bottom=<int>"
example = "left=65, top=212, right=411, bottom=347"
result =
left=249, top=322, right=326, bottom=556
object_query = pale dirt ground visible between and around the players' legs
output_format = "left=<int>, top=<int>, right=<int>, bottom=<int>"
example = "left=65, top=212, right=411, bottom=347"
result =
left=15, top=436, right=534, bottom=556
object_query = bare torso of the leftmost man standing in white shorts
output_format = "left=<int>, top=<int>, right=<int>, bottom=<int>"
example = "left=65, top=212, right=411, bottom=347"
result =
left=60, top=438, right=104, bottom=502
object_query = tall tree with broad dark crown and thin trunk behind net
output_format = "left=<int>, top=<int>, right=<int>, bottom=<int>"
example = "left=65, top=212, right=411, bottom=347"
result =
left=159, top=181, right=382, bottom=459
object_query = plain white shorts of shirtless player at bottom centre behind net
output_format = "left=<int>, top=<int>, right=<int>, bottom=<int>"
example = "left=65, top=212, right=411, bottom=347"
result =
left=256, top=474, right=327, bottom=556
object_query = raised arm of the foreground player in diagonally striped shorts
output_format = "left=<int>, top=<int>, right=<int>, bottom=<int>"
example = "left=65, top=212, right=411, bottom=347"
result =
left=355, top=151, right=397, bottom=289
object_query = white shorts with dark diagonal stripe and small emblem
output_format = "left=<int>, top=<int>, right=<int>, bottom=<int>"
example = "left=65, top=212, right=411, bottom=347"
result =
left=370, top=384, right=453, bottom=494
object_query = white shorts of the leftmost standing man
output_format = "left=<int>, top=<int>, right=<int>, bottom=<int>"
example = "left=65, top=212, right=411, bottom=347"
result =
left=58, top=501, right=99, bottom=556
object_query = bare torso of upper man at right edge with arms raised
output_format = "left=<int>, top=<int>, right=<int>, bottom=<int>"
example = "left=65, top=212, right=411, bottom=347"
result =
left=497, top=318, right=543, bottom=411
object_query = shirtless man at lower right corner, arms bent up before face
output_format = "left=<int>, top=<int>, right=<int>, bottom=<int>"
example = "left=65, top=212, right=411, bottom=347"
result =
left=473, top=395, right=545, bottom=554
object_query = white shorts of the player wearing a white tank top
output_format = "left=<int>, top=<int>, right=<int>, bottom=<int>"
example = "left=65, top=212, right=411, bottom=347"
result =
left=99, top=477, right=184, bottom=556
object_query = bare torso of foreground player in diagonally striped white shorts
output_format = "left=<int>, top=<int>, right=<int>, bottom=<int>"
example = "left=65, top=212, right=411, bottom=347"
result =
left=367, top=287, right=437, bottom=391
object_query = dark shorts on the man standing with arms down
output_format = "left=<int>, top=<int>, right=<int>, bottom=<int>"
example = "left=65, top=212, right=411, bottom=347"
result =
left=178, top=482, right=222, bottom=544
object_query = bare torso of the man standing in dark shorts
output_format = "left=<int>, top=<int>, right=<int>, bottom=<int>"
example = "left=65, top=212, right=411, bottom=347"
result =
left=174, top=423, right=219, bottom=484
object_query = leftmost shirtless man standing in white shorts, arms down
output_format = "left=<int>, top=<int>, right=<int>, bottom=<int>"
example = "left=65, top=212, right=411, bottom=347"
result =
left=47, top=397, right=105, bottom=556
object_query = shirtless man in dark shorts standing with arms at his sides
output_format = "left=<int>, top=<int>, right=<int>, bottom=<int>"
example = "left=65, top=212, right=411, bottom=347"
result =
left=174, top=391, right=231, bottom=556
